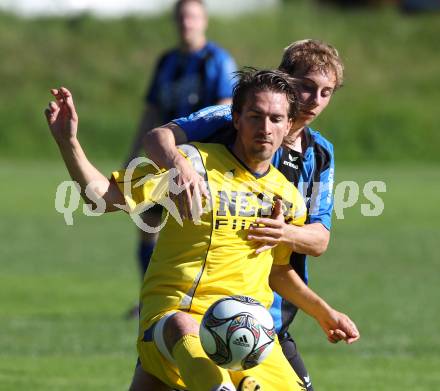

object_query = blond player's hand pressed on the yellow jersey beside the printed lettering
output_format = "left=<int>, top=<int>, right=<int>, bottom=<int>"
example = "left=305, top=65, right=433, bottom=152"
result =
left=247, top=200, right=286, bottom=254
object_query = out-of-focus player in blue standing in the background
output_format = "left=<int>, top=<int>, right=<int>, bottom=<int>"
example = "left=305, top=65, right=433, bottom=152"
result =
left=123, top=0, right=236, bottom=288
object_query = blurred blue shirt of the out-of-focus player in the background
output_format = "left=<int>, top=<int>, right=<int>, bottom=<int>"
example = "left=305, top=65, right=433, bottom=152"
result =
left=146, top=42, right=237, bottom=122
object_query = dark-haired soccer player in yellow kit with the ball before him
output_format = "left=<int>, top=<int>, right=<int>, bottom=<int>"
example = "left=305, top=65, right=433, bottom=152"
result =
left=46, top=71, right=359, bottom=391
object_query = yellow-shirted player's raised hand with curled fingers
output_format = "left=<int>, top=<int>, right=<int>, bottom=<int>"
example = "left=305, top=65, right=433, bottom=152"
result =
left=44, top=87, right=78, bottom=143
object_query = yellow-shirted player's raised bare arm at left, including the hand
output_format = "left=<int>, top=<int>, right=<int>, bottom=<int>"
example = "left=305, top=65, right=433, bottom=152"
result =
left=44, top=87, right=125, bottom=212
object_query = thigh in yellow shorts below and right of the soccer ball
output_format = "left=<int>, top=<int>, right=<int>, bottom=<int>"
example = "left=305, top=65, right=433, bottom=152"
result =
left=231, top=340, right=305, bottom=391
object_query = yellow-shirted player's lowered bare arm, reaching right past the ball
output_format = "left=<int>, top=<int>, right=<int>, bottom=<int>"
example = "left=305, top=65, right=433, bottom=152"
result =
left=269, top=265, right=360, bottom=343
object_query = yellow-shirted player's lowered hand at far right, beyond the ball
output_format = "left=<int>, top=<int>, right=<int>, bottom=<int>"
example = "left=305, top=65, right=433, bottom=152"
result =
left=318, top=309, right=360, bottom=344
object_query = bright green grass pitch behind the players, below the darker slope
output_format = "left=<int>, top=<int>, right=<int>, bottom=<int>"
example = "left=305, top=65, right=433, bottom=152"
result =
left=0, top=160, right=440, bottom=391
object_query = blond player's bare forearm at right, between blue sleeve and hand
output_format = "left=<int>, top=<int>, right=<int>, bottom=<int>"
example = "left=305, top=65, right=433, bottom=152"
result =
left=286, top=223, right=330, bottom=257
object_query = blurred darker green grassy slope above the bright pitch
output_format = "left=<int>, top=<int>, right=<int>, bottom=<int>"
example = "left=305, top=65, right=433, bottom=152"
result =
left=0, top=0, right=440, bottom=164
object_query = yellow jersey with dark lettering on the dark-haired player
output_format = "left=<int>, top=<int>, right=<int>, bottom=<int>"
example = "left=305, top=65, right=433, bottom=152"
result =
left=113, top=143, right=306, bottom=333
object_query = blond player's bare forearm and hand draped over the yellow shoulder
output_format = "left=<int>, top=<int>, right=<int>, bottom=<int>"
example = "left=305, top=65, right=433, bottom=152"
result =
left=144, top=122, right=209, bottom=218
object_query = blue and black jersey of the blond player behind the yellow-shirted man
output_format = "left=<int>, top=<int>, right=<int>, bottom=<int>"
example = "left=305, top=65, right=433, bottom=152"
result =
left=173, top=105, right=334, bottom=338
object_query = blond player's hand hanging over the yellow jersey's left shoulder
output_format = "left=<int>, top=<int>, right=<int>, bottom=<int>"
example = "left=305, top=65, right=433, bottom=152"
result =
left=173, top=158, right=209, bottom=221
